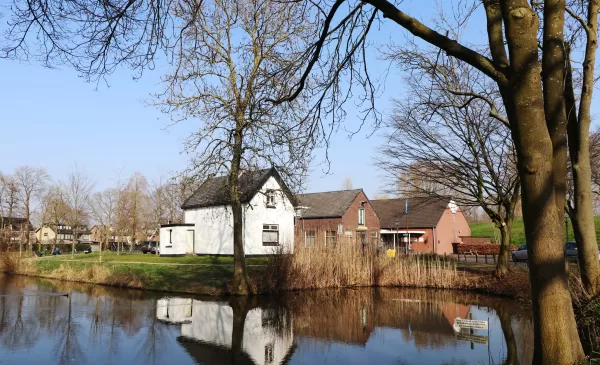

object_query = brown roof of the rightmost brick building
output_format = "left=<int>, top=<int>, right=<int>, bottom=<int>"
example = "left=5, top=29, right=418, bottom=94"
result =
left=371, top=198, right=448, bottom=229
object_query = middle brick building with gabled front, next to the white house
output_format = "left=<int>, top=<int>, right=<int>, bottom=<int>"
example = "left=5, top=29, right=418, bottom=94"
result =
left=294, top=189, right=380, bottom=247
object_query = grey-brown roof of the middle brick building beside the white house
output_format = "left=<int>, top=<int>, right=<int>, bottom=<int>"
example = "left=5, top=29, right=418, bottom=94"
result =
left=298, top=189, right=362, bottom=218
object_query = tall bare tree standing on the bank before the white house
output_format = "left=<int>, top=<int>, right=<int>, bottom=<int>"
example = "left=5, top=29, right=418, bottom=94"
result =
left=159, top=0, right=320, bottom=294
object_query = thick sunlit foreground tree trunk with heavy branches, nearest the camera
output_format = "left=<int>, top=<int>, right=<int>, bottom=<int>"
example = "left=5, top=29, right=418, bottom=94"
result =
left=501, top=0, right=585, bottom=365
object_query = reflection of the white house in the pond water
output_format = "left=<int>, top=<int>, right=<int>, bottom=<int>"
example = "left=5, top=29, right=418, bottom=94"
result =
left=156, top=298, right=294, bottom=365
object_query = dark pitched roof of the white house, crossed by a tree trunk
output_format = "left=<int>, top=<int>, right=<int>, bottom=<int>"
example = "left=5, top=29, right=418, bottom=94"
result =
left=181, top=167, right=294, bottom=209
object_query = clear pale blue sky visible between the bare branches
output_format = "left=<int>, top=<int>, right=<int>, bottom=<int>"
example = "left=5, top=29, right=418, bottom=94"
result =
left=0, top=1, right=596, bottom=197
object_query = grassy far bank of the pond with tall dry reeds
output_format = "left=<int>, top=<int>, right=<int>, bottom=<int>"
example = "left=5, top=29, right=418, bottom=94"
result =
left=0, top=247, right=528, bottom=298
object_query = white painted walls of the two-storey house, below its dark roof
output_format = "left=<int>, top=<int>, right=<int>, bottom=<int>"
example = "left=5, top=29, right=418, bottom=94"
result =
left=183, top=177, right=294, bottom=255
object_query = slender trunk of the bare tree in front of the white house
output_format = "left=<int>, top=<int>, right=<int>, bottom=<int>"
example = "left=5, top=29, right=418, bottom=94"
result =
left=229, top=120, right=249, bottom=295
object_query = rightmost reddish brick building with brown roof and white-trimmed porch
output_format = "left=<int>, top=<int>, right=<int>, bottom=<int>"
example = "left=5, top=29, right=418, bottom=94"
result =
left=371, top=198, right=471, bottom=254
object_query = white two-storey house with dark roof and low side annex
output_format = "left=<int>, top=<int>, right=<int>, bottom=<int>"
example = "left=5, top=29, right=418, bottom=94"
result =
left=160, top=168, right=294, bottom=256
